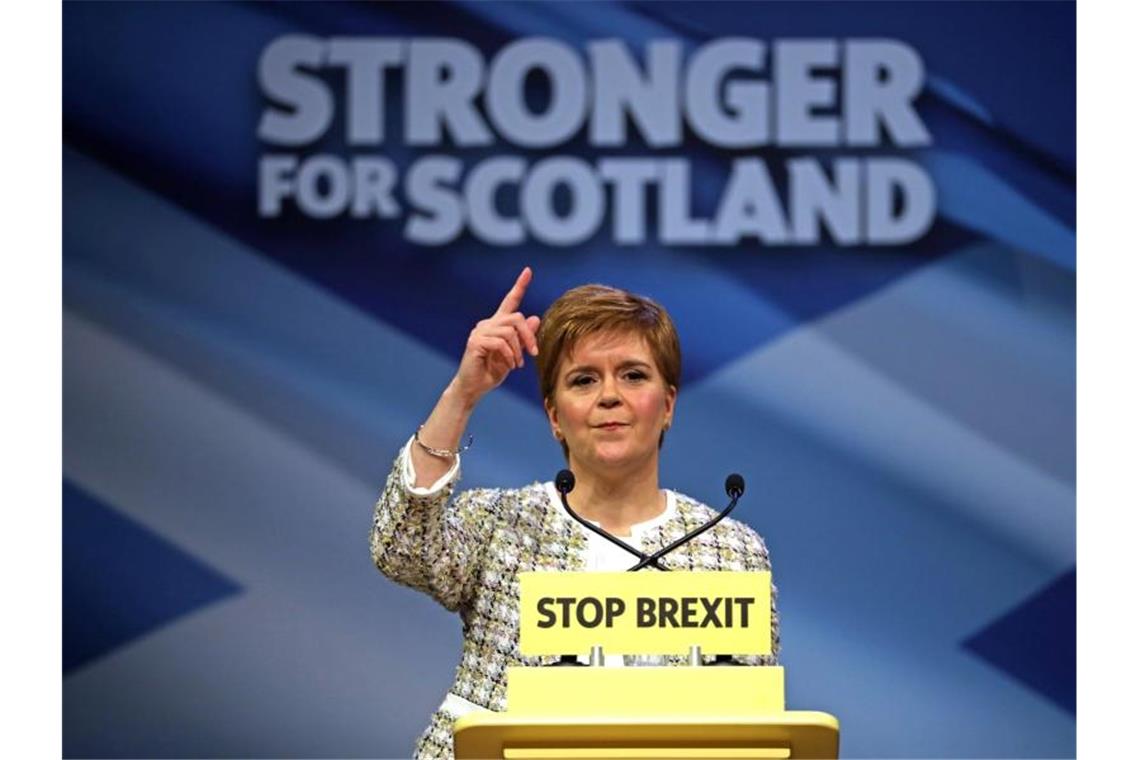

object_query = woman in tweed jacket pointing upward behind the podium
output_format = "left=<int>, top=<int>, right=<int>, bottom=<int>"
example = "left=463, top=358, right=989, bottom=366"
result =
left=372, top=268, right=780, bottom=758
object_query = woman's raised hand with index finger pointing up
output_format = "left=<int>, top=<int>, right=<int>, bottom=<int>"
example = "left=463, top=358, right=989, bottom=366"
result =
left=453, top=267, right=539, bottom=404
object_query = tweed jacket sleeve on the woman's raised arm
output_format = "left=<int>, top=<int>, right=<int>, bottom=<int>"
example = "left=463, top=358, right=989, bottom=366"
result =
left=371, top=447, right=500, bottom=612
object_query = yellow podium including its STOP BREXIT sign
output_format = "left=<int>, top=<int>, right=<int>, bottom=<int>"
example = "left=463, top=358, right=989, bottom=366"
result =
left=454, top=573, right=839, bottom=760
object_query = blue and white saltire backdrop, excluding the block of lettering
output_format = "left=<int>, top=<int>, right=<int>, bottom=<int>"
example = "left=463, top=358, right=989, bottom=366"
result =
left=63, top=2, right=1076, bottom=757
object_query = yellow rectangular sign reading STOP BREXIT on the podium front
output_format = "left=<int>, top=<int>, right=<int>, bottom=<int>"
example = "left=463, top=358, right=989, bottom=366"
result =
left=519, top=571, right=772, bottom=656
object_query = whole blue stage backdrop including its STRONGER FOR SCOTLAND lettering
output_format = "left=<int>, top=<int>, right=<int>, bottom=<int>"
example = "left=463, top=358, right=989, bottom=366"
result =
left=63, top=1, right=1076, bottom=758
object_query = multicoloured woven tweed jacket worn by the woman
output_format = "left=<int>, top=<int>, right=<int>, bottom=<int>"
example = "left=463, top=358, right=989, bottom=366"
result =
left=371, top=451, right=780, bottom=759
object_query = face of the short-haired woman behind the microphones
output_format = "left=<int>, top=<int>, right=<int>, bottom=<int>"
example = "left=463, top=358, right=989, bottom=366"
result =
left=546, top=332, right=677, bottom=471
